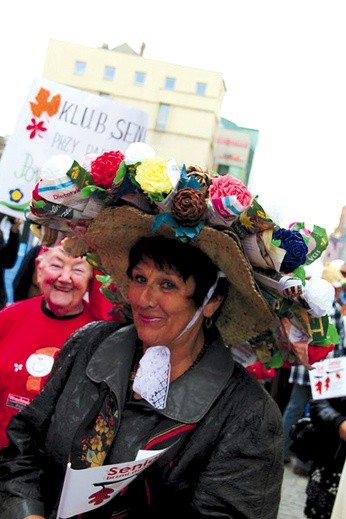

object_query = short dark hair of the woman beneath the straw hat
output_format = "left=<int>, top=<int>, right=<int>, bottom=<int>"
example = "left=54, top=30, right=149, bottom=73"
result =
left=126, top=235, right=229, bottom=308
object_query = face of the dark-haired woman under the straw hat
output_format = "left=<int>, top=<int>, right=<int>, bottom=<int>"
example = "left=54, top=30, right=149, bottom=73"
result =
left=128, top=259, right=196, bottom=347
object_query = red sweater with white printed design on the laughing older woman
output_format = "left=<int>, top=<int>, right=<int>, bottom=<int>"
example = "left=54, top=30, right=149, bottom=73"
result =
left=0, top=296, right=94, bottom=448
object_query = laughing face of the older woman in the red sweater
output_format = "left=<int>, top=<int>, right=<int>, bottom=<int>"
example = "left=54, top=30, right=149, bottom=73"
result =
left=37, top=247, right=92, bottom=316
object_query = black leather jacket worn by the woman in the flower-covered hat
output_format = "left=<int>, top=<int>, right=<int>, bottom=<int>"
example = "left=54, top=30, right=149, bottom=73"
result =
left=0, top=322, right=283, bottom=519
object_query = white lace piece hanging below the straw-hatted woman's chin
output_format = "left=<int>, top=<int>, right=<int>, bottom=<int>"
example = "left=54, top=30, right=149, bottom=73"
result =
left=133, top=346, right=171, bottom=409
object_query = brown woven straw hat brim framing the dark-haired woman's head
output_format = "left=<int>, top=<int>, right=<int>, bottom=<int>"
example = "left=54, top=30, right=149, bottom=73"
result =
left=85, top=206, right=274, bottom=345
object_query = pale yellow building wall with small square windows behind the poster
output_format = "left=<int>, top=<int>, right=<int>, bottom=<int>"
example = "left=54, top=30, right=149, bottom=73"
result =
left=43, top=40, right=226, bottom=167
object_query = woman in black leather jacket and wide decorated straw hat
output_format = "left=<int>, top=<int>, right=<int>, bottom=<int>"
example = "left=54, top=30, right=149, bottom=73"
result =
left=0, top=147, right=283, bottom=519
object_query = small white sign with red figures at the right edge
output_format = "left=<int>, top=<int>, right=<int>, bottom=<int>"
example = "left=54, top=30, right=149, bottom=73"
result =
left=309, top=357, right=346, bottom=400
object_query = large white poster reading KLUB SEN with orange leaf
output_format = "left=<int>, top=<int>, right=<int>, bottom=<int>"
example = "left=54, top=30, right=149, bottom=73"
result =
left=0, top=79, right=149, bottom=217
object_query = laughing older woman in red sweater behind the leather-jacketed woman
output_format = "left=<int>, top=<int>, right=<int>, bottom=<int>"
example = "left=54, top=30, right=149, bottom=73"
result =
left=0, top=244, right=94, bottom=447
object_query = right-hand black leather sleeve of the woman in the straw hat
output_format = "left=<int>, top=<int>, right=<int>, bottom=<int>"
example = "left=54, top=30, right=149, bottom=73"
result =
left=188, top=381, right=284, bottom=519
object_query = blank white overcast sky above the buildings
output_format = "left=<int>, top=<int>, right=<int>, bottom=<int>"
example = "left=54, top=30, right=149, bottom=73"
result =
left=0, top=0, right=346, bottom=236
